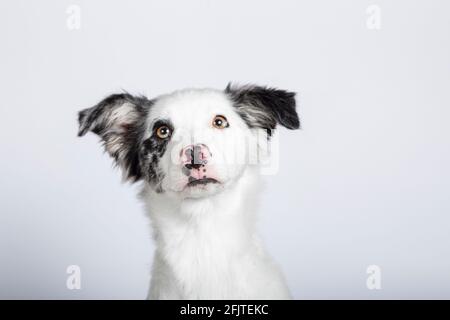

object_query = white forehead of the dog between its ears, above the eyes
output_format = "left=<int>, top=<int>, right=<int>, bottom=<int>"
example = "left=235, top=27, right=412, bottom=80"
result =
left=149, top=89, right=232, bottom=123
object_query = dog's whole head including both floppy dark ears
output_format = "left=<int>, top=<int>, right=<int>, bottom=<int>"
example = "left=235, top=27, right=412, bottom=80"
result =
left=79, top=86, right=299, bottom=198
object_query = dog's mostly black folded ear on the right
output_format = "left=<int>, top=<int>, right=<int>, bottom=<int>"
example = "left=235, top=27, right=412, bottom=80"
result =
left=225, top=83, right=300, bottom=134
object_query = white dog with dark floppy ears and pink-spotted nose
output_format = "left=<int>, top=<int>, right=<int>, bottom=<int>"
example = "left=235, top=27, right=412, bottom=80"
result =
left=78, top=84, right=300, bottom=299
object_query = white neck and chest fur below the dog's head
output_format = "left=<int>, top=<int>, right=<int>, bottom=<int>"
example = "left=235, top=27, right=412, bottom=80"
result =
left=143, top=170, right=290, bottom=299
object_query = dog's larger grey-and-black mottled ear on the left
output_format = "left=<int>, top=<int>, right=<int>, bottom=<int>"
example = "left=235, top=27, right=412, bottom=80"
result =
left=78, top=93, right=152, bottom=182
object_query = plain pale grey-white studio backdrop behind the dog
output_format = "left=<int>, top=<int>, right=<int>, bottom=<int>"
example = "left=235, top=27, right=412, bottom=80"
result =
left=0, top=0, right=450, bottom=299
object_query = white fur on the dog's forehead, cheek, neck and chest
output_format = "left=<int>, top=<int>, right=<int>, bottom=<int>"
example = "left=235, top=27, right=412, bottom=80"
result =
left=137, top=90, right=290, bottom=299
